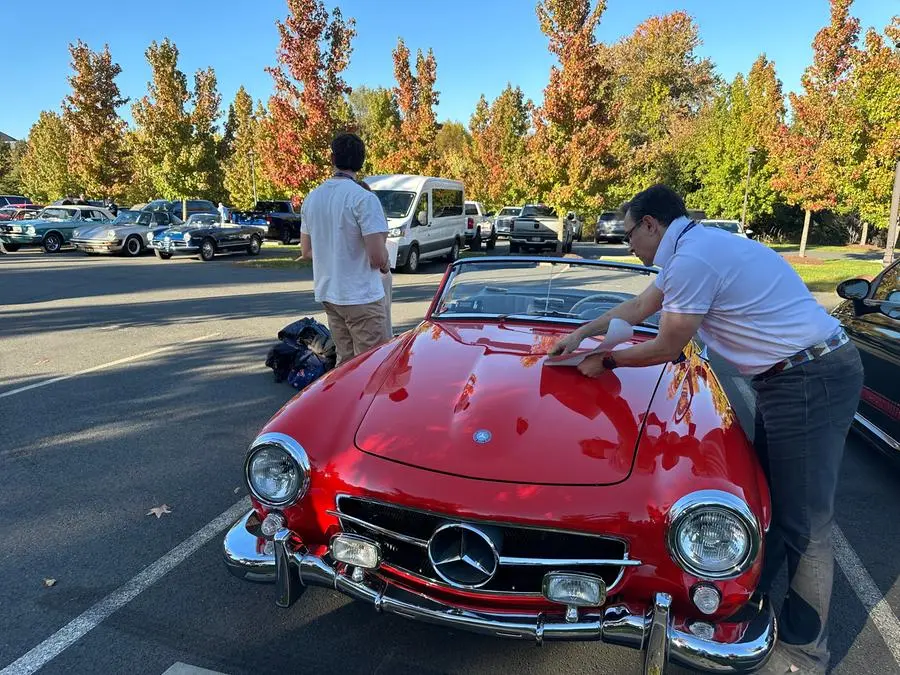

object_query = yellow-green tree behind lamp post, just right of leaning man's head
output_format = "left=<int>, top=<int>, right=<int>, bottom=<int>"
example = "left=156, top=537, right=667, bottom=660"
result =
left=688, top=56, right=785, bottom=222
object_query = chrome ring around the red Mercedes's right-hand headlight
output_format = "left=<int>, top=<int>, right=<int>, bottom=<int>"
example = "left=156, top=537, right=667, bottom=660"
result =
left=666, top=490, right=762, bottom=580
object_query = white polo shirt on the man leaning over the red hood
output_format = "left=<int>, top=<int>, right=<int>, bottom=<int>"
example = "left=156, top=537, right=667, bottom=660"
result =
left=653, top=218, right=840, bottom=375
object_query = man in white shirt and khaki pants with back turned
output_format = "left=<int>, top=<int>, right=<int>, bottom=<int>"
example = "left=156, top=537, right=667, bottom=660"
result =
left=300, top=133, right=388, bottom=363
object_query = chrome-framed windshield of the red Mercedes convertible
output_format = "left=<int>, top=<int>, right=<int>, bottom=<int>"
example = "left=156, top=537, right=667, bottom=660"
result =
left=433, top=260, right=659, bottom=326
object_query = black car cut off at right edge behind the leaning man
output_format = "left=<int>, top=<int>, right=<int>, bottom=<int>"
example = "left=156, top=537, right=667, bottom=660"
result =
left=833, top=260, right=900, bottom=459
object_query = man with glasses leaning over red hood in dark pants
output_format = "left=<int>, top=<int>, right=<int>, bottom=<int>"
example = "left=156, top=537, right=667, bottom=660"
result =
left=551, top=185, right=863, bottom=675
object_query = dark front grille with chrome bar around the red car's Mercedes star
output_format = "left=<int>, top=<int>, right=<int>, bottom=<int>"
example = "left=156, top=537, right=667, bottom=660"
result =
left=333, top=495, right=641, bottom=595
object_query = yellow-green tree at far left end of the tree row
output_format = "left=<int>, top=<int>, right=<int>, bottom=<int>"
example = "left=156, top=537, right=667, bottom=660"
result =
left=22, top=111, right=76, bottom=204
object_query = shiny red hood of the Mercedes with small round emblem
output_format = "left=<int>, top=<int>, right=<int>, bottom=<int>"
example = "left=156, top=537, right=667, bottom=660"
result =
left=356, top=322, right=662, bottom=485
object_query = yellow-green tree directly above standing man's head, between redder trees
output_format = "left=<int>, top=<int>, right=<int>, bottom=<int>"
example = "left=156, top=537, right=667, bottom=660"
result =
left=348, top=86, right=400, bottom=175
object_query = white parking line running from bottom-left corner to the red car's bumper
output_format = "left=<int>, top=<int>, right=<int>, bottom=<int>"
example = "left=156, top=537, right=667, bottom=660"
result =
left=0, top=497, right=250, bottom=675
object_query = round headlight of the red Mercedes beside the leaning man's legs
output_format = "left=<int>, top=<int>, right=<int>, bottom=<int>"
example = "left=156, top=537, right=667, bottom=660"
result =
left=669, top=490, right=760, bottom=579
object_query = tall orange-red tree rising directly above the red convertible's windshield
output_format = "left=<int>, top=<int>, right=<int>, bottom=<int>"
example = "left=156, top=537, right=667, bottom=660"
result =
left=526, top=0, right=614, bottom=217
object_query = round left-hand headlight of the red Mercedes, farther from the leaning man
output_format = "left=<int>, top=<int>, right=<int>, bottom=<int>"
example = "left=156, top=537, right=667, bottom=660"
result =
left=245, top=433, right=309, bottom=506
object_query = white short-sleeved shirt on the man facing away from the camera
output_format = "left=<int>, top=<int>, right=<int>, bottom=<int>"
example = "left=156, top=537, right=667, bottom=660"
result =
left=300, top=177, right=388, bottom=305
